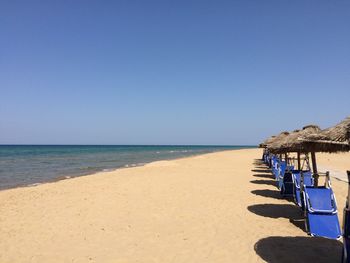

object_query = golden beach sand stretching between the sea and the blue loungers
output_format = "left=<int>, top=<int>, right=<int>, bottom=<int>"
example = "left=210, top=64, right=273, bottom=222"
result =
left=0, top=149, right=350, bottom=263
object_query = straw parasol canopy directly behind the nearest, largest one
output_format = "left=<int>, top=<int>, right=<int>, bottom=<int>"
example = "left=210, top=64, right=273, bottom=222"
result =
left=270, top=124, right=321, bottom=153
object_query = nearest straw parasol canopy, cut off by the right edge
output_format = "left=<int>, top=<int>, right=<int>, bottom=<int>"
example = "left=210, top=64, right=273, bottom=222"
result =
left=298, top=117, right=350, bottom=152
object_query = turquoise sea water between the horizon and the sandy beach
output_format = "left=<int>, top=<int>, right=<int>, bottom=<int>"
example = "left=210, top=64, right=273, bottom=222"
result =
left=0, top=145, right=251, bottom=189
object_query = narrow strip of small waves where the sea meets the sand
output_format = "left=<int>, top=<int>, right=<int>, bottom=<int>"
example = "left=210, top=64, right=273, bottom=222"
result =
left=0, top=146, right=258, bottom=192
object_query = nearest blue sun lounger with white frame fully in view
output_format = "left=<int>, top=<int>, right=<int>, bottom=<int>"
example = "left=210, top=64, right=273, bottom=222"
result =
left=303, top=173, right=341, bottom=239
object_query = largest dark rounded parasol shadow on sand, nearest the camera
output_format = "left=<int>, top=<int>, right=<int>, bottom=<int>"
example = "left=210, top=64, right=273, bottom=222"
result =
left=254, top=236, right=342, bottom=263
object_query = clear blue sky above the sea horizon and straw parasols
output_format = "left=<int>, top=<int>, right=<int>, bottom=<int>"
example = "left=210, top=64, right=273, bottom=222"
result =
left=0, top=0, right=350, bottom=144
